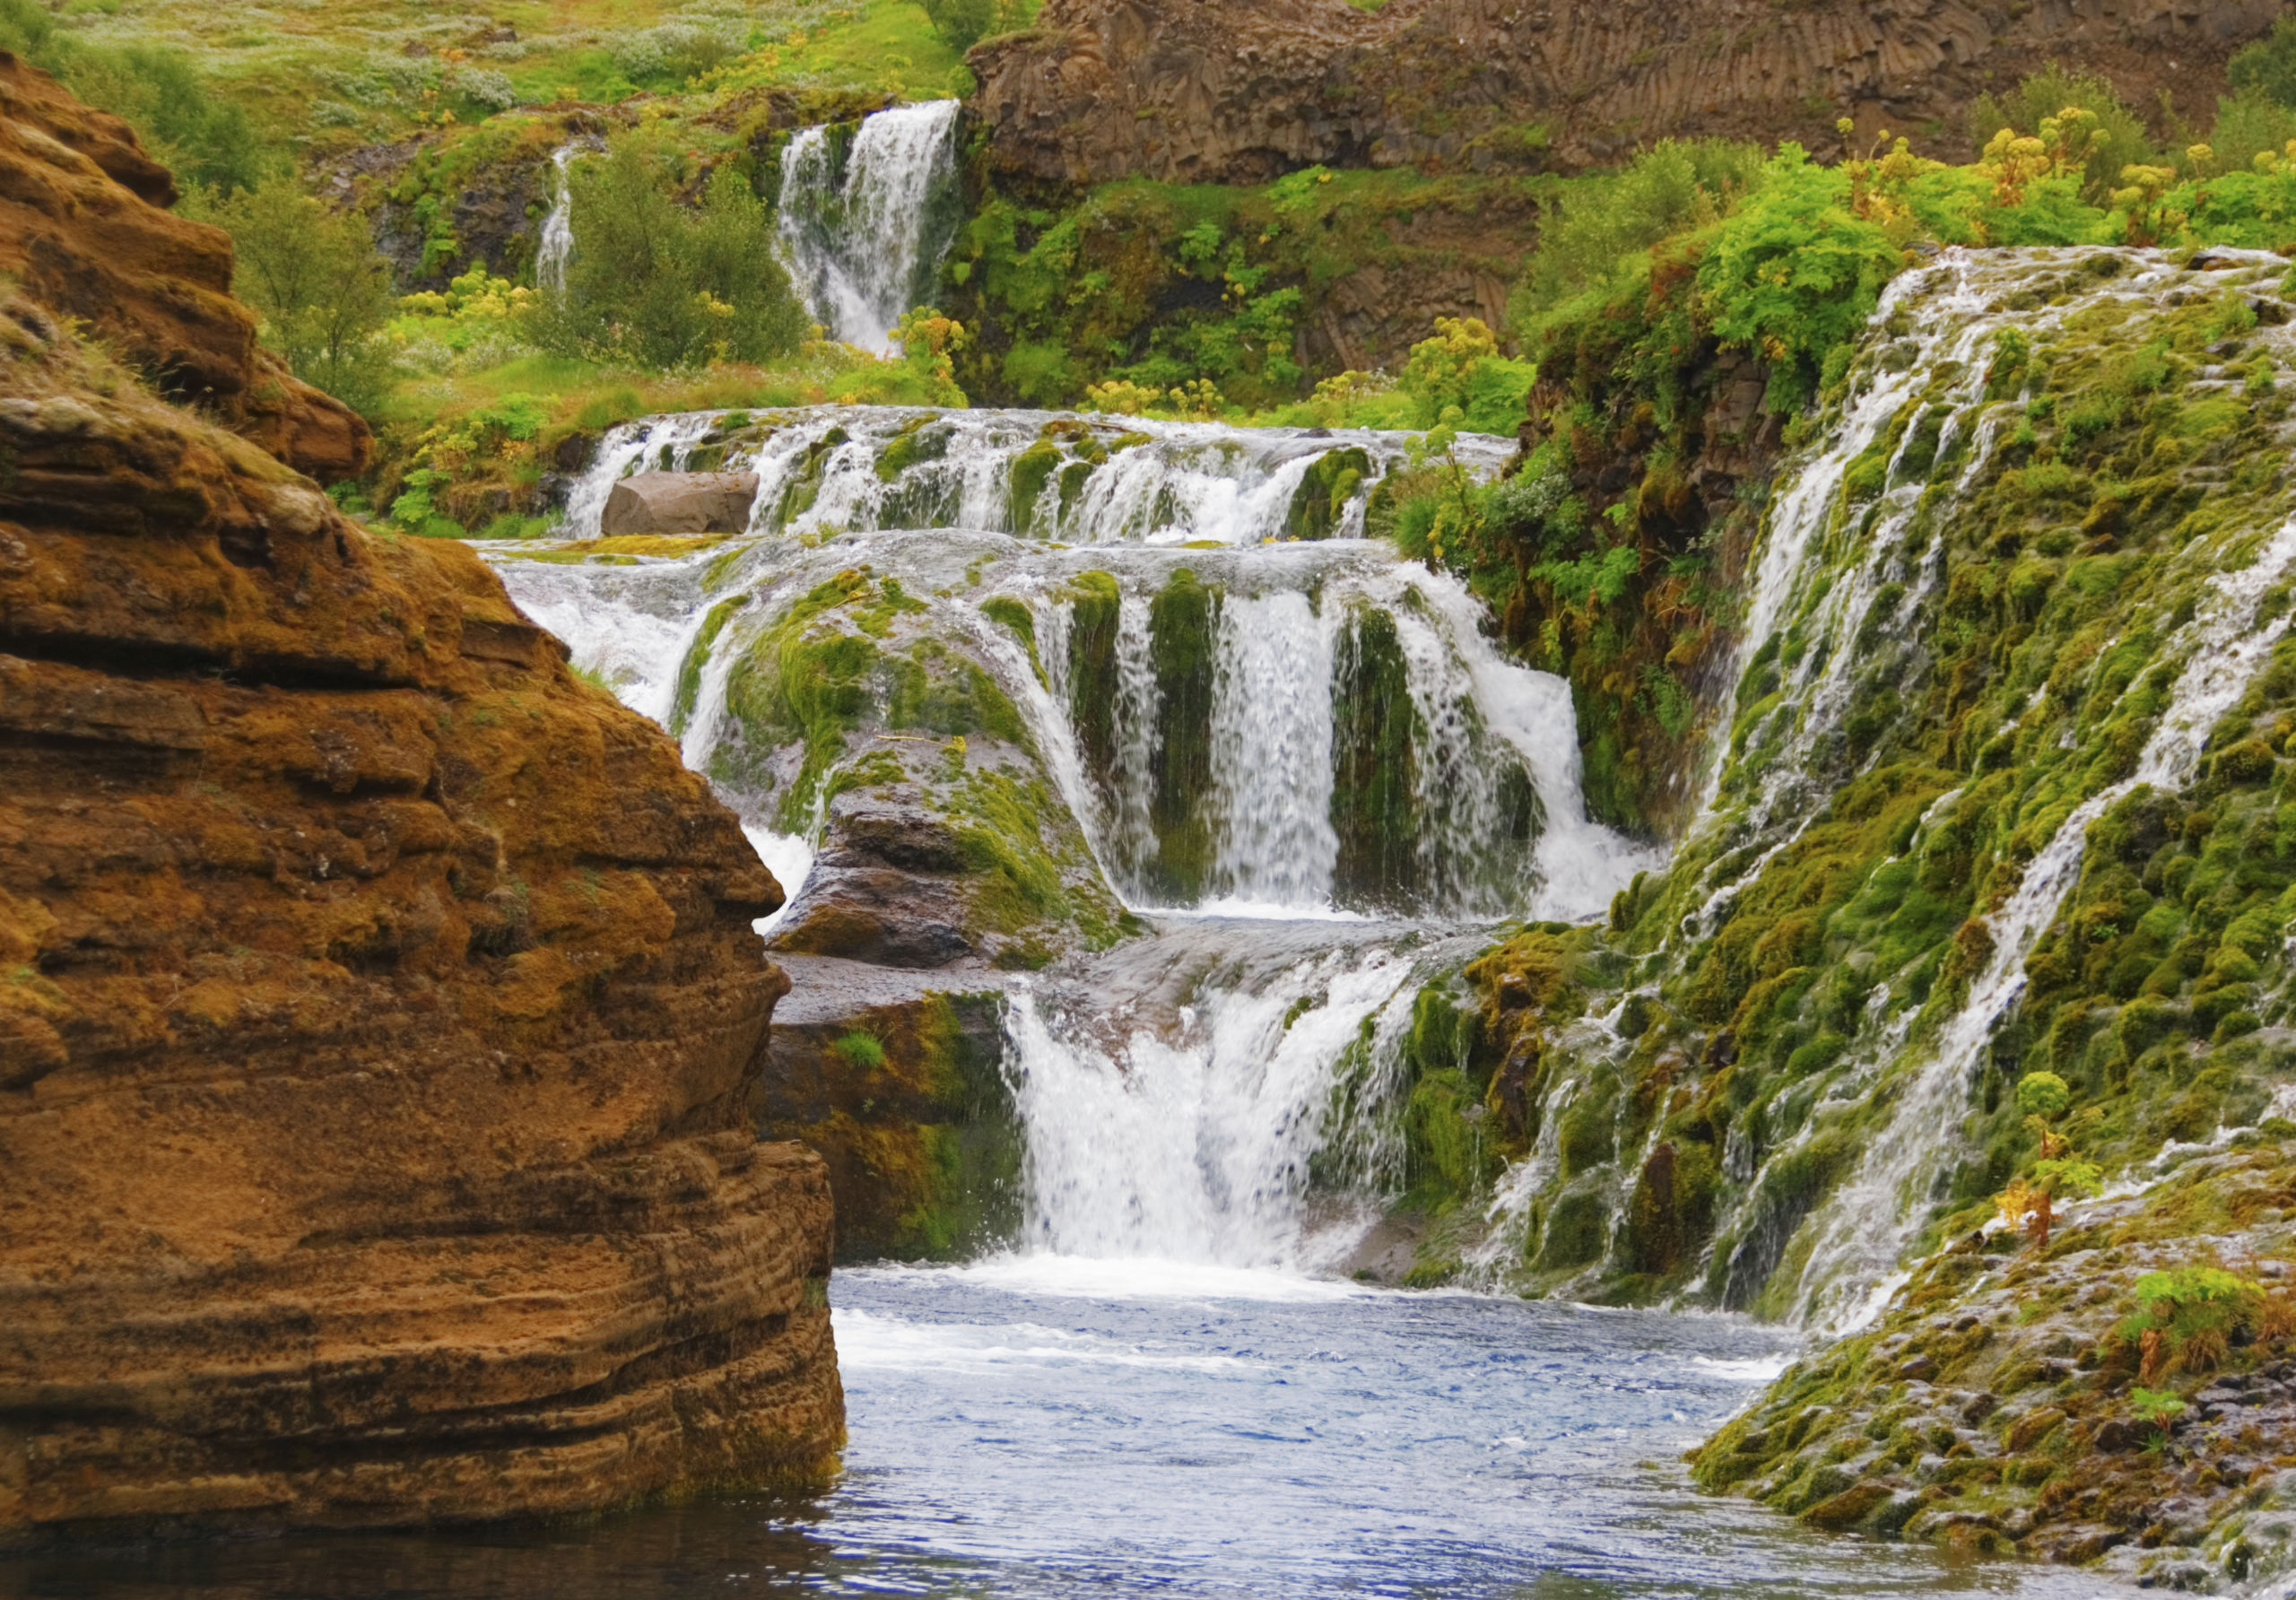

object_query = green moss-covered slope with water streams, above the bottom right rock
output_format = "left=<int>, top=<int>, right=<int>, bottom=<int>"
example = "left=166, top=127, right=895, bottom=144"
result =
left=1469, top=250, right=2296, bottom=1329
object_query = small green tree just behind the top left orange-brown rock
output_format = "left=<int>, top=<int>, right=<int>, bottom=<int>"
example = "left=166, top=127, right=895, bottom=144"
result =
left=202, top=177, right=393, bottom=411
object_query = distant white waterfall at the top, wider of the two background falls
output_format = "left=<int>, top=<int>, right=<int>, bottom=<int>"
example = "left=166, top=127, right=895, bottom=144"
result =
left=780, top=101, right=962, bottom=353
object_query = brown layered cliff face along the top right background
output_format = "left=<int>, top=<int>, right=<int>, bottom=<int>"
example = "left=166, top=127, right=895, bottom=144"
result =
left=971, top=0, right=2280, bottom=184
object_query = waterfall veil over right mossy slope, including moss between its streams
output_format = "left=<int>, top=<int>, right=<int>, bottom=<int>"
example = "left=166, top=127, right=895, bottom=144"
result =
left=1432, top=250, right=2296, bottom=1332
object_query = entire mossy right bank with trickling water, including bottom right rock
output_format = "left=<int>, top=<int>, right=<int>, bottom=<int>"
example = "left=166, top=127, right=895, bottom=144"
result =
left=1368, top=250, right=2296, bottom=1587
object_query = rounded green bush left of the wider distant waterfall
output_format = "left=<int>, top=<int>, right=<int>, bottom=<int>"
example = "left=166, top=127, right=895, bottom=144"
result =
left=528, top=131, right=811, bottom=370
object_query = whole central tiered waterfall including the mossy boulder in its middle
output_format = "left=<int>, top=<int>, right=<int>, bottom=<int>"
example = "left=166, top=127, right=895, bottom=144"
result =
left=493, top=409, right=1660, bottom=1265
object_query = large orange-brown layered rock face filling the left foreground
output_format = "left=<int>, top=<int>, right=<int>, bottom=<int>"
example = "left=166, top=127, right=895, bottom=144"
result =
left=0, top=56, right=843, bottom=1545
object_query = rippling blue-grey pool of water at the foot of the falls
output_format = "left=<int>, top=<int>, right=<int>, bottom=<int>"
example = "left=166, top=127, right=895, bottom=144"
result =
left=0, top=1256, right=2108, bottom=1600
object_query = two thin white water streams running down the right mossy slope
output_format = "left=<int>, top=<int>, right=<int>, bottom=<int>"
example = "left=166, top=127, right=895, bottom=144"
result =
left=1450, top=250, right=2296, bottom=1329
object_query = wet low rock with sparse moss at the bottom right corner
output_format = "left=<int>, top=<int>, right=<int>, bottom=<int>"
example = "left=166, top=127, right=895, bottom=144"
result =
left=1692, top=1136, right=2296, bottom=1593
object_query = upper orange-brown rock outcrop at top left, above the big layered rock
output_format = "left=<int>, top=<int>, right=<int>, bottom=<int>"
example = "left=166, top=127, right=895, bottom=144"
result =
left=0, top=50, right=372, bottom=483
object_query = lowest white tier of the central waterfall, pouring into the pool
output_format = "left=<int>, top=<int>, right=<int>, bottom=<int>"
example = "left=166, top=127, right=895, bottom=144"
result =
left=1005, top=923, right=1474, bottom=1267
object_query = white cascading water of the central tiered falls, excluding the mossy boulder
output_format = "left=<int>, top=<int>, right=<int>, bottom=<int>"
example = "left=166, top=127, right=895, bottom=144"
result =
left=500, top=406, right=1657, bottom=1265
